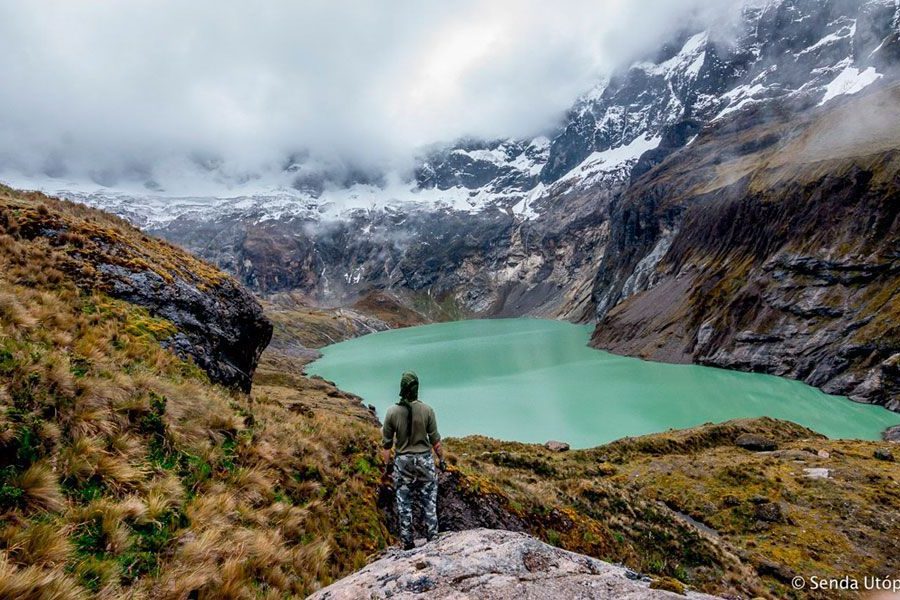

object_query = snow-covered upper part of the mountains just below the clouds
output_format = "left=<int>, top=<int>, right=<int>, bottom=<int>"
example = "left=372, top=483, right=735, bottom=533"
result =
left=3, top=0, right=900, bottom=228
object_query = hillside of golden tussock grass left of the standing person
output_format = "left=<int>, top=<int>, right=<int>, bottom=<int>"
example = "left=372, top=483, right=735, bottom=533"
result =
left=0, top=188, right=388, bottom=599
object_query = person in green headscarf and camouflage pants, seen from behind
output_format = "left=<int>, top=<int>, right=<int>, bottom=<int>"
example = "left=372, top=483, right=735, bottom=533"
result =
left=382, top=372, right=447, bottom=550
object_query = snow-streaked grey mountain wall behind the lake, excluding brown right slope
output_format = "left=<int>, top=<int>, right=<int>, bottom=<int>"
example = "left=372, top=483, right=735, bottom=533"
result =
left=0, top=0, right=900, bottom=318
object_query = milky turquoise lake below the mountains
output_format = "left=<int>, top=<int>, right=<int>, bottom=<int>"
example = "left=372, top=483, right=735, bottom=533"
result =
left=307, top=319, right=900, bottom=448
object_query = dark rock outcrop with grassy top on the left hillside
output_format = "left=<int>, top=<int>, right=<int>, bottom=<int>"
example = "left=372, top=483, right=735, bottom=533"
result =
left=0, top=188, right=272, bottom=391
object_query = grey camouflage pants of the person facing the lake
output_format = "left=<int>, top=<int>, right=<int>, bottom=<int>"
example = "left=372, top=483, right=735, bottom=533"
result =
left=394, top=452, right=437, bottom=545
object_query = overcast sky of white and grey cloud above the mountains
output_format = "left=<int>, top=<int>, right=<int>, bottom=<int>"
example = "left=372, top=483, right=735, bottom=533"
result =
left=0, top=0, right=735, bottom=188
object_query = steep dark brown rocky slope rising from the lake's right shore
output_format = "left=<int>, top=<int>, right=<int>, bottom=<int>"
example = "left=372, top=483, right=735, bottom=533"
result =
left=592, top=85, right=900, bottom=410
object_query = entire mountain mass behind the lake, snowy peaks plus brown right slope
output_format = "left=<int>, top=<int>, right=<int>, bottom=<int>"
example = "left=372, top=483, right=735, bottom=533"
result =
left=0, top=0, right=900, bottom=409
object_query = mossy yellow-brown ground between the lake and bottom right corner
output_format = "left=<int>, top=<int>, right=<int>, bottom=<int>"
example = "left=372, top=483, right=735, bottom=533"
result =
left=448, top=419, right=900, bottom=599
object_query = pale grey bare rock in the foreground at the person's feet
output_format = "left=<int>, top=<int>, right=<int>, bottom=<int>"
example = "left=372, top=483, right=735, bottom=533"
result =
left=310, top=529, right=714, bottom=600
